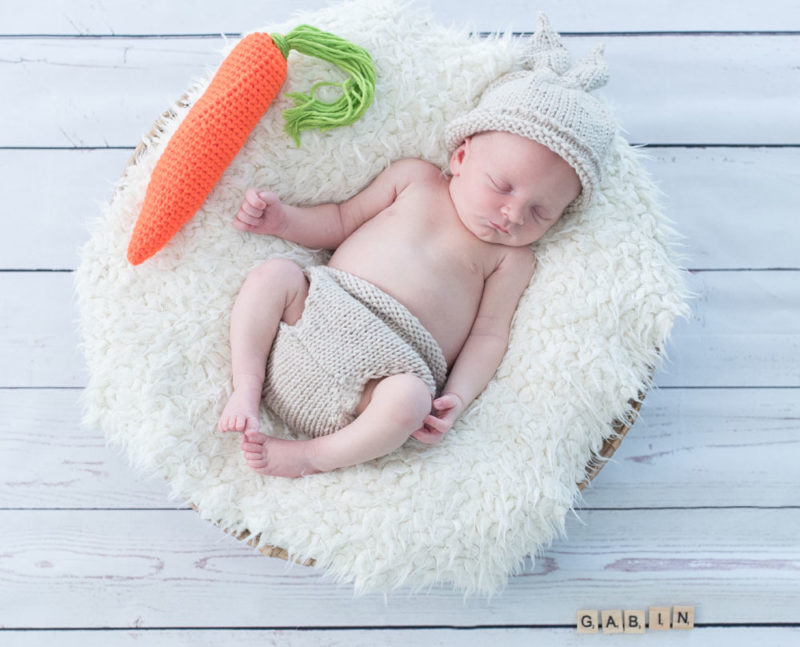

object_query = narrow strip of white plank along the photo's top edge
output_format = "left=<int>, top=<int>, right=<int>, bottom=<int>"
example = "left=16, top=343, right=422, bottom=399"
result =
left=0, top=0, right=800, bottom=36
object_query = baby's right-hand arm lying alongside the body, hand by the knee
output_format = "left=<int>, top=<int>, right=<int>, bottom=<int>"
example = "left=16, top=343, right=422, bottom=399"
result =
left=412, top=247, right=536, bottom=443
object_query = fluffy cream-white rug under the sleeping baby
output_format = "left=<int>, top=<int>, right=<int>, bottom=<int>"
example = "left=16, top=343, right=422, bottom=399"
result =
left=76, top=0, right=685, bottom=594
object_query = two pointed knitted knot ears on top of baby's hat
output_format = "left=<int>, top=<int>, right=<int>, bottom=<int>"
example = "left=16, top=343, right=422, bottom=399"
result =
left=522, top=13, right=608, bottom=92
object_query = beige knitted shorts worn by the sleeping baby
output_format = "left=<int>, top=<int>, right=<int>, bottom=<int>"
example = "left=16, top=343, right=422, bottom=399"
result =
left=264, top=266, right=447, bottom=437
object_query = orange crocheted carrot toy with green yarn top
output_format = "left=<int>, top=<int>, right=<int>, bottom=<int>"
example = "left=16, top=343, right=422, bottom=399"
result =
left=128, top=25, right=375, bottom=265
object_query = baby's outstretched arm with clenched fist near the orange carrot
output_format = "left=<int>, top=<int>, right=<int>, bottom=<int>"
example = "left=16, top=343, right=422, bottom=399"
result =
left=233, top=159, right=430, bottom=249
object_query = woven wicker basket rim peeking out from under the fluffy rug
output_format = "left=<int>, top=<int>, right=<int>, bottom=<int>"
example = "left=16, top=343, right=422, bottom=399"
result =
left=126, top=104, right=645, bottom=566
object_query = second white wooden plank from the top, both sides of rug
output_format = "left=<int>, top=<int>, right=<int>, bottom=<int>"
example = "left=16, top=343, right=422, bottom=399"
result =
left=0, top=35, right=800, bottom=147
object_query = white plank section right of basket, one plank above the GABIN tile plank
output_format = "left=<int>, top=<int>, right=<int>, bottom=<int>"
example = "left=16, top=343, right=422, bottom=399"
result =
left=583, top=388, right=800, bottom=508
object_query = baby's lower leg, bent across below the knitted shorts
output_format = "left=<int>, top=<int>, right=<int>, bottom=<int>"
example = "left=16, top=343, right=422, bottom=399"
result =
left=242, top=374, right=431, bottom=476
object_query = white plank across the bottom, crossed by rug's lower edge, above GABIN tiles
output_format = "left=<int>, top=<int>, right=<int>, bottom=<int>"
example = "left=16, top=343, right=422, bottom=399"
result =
left=0, top=509, right=800, bottom=628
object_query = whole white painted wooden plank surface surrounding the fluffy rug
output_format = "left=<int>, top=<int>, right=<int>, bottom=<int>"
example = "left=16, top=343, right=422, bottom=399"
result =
left=0, top=0, right=800, bottom=647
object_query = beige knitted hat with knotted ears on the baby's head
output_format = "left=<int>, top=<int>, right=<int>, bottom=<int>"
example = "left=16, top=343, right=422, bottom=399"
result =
left=445, top=14, right=616, bottom=209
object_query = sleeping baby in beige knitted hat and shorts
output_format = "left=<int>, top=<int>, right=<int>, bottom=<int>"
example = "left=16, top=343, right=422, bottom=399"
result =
left=219, top=17, right=615, bottom=477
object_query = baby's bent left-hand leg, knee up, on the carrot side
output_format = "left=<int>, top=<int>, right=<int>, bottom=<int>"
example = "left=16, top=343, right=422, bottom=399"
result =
left=219, top=258, right=308, bottom=431
